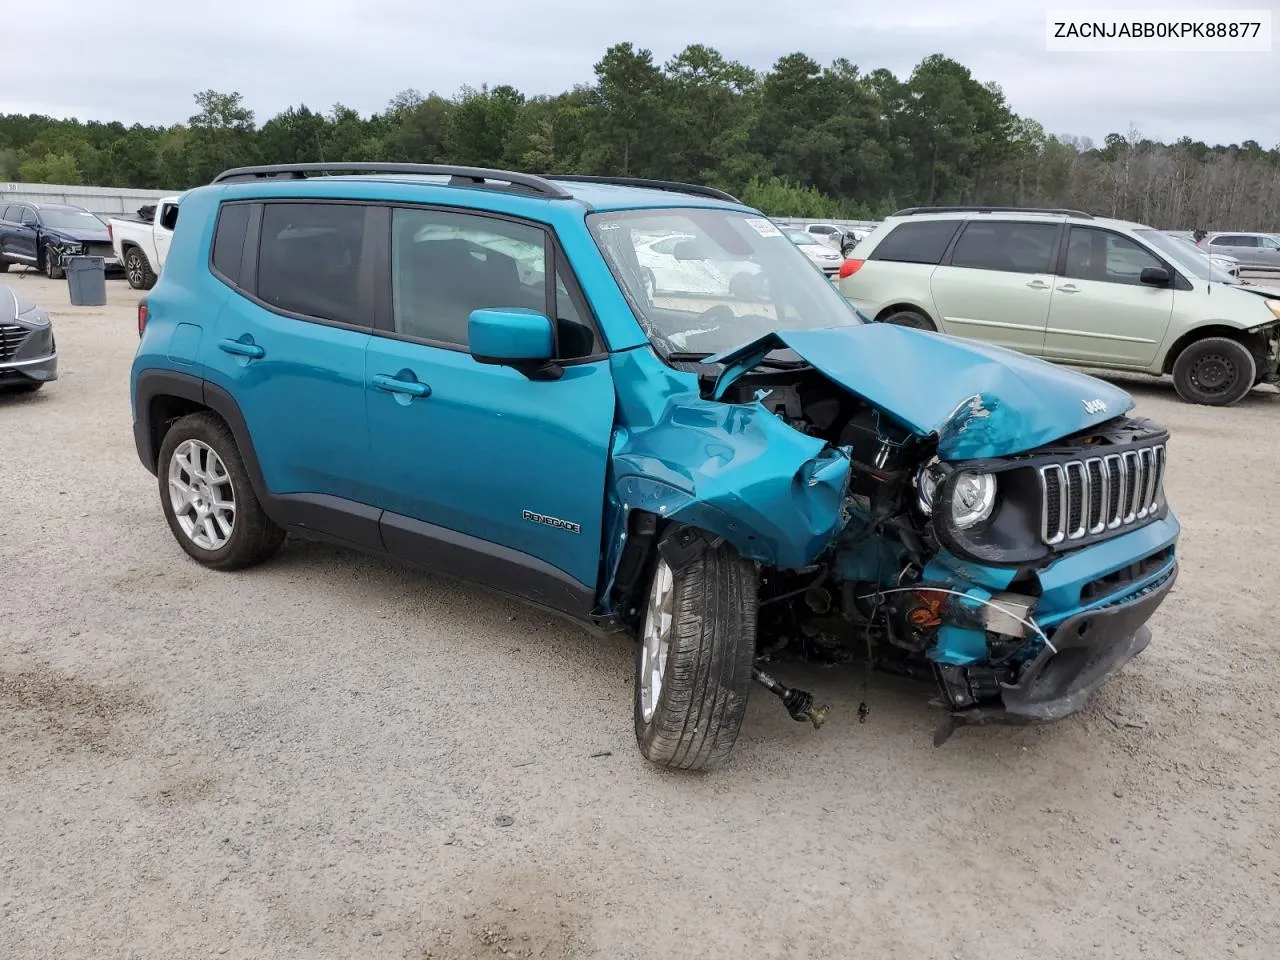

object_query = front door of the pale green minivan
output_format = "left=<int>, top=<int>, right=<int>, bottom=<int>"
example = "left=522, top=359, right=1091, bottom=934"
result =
left=1044, top=224, right=1176, bottom=367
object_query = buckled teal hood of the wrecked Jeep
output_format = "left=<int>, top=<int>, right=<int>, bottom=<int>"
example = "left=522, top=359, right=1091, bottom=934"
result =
left=703, top=324, right=1134, bottom=461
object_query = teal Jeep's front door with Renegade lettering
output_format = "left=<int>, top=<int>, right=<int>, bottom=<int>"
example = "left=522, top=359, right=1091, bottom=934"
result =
left=365, top=207, right=614, bottom=612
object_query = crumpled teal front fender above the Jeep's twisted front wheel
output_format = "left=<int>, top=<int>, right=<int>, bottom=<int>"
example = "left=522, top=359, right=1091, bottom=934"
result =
left=612, top=393, right=849, bottom=570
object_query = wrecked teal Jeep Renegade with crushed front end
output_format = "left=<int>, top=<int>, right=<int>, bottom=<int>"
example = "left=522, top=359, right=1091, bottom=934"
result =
left=131, top=164, right=1179, bottom=768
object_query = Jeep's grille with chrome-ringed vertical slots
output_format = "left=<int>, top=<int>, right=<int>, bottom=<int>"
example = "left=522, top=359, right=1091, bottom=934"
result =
left=1039, top=443, right=1165, bottom=547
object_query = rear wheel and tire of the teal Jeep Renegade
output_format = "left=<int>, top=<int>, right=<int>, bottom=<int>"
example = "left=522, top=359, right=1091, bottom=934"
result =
left=156, top=411, right=284, bottom=570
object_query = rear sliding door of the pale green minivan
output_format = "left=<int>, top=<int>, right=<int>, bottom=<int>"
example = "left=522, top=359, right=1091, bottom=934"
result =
left=929, top=219, right=1062, bottom=356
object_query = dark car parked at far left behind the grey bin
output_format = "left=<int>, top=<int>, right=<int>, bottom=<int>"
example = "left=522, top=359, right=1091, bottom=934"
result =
left=0, top=202, right=119, bottom=280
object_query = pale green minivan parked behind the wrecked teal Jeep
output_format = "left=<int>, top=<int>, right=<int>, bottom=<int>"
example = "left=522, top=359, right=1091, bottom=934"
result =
left=840, top=207, right=1280, bottom=406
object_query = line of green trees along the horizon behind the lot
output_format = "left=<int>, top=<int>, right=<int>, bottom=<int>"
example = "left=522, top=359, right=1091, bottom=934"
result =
left=0, top=44, right=1280, bottom=230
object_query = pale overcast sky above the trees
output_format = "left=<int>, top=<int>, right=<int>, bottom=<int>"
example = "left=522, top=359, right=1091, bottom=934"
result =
left=0, top=0, right=1280, bottom=147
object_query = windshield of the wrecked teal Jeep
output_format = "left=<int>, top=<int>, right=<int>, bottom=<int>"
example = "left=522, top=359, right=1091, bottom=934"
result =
left=586, top=209, right=861, bottom=356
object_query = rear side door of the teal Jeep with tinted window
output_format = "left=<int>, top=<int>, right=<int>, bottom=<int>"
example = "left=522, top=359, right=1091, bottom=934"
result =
left=202, top=202, right=376, bottom=549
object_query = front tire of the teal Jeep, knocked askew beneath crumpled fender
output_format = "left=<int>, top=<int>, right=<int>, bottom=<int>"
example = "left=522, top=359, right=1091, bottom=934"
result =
left=635, top=543, right=759, bottom=771
